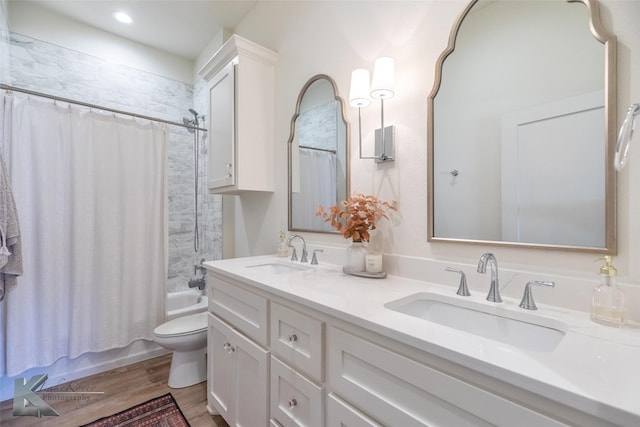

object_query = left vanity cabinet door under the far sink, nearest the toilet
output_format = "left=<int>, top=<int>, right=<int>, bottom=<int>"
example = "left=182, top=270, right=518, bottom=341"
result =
left=207, top=314, right=234, bottom=420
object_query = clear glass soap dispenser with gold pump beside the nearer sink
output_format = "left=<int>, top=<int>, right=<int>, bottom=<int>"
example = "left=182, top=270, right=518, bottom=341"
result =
left=591, top=255, right=625, bottom=327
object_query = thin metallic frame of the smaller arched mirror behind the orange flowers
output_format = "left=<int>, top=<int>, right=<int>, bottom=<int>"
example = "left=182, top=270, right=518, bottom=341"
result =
left=287, top=74, right=351, bottom=234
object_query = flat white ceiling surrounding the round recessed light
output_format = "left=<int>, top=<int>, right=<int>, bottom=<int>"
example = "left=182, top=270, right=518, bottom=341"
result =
left=20, top=0, right=257, bottom=60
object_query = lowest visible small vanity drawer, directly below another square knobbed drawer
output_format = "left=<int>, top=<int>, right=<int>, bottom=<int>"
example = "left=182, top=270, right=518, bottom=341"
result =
left=271, top=356, right=324, bottom=427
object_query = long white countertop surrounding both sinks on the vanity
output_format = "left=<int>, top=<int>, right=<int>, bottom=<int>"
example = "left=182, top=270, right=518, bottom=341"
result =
left=204, top=256, right=640, bottom=426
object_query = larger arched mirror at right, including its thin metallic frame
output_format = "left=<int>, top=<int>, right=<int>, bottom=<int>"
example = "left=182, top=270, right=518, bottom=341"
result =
left=428, top=0, right=616, bottom=253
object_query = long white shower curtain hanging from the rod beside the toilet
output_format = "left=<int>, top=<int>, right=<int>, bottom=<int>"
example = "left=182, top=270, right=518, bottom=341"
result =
left=0, top=95, right=167, bottom=376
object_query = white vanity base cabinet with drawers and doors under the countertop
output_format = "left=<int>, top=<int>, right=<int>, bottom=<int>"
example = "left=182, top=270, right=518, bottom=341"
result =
left=208, top=264, right=615, bottom=427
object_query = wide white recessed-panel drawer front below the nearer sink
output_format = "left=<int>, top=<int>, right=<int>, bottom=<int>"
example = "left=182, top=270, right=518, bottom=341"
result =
left=327, top=327, right=564, bottom=427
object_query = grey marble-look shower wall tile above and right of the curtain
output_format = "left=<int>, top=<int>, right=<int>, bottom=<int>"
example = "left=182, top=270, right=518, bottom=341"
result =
left=0, top=32, right=222, bottom=292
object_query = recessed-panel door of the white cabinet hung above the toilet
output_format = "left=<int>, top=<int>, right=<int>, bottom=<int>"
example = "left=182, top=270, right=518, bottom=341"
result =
left=207, top=62, right=236, bottom=188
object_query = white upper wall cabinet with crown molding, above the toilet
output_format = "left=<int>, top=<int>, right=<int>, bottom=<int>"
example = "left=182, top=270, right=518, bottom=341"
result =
left=199, top=35, right=277, bottom=194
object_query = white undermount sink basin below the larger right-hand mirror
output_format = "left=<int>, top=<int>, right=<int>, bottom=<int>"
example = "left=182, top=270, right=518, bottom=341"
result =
left=385, top=292, right=567, bottom=352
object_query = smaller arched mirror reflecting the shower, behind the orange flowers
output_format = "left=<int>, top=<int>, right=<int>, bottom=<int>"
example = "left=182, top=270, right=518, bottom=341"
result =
left=288, top=74, right=349, bottom=233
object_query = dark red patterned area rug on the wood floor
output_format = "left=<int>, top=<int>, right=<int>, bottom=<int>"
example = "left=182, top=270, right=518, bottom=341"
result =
left=81, top=393, right=189, bottom=427
